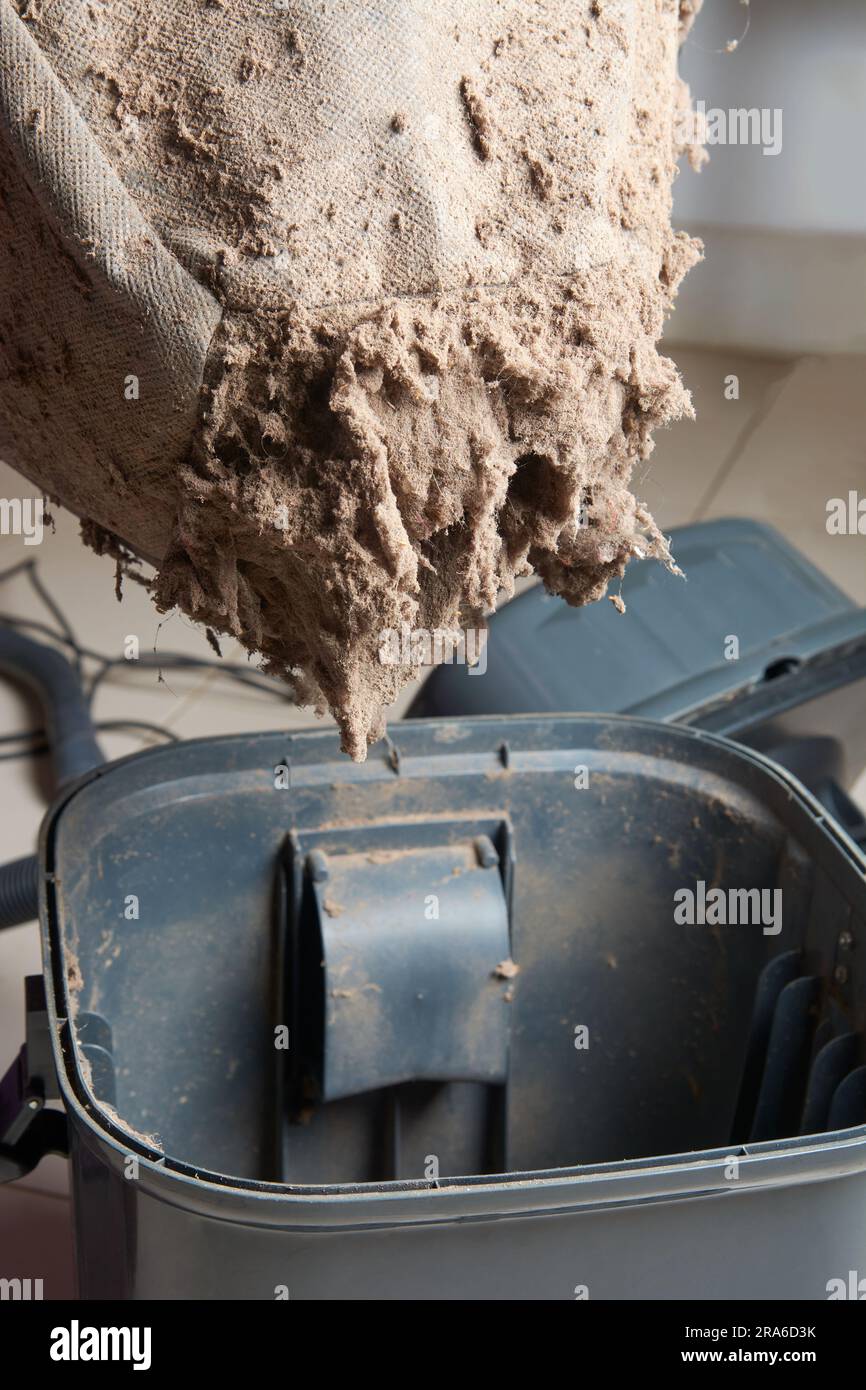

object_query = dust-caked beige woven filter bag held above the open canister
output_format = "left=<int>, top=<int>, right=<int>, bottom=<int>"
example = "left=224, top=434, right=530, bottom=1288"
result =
left=0, top=0, right=701, bottom=758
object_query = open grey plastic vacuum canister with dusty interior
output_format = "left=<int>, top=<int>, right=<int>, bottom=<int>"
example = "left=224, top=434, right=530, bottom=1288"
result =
left=16, top=716, right=866, bottom=1300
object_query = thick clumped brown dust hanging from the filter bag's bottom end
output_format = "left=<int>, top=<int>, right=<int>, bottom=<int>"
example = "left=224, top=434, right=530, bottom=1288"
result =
left=157, top=261, right=692, bottom=758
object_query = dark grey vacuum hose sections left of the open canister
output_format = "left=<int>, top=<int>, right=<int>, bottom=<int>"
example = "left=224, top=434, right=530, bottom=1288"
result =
left=0, top=627, right=106, bottom=929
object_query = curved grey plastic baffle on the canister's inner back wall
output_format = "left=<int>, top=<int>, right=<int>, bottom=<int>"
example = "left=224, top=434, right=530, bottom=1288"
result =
left=284, top=820, right=513, bottom=1106
